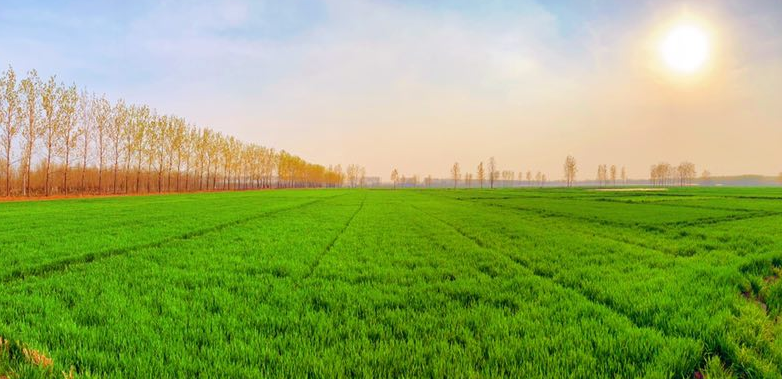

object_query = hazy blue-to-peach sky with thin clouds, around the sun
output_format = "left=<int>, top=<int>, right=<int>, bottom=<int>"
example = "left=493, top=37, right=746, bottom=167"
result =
left=0, top=0, right=782, bottom=180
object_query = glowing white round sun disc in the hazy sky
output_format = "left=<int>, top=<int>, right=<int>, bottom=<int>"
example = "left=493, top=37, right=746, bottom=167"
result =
left=660, top=24, right=710, bottom=74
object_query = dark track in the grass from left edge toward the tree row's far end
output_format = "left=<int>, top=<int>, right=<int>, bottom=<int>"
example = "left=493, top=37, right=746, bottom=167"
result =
left=0, top=195, right=344, bottom=284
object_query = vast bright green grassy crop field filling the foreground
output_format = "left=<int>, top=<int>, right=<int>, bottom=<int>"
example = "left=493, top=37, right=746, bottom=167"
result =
left=0, top=188, right=782, bottom=378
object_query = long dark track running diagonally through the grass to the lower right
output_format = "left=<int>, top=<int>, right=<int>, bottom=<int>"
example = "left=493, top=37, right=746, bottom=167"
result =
left=413, top=206, right=691, bottom=338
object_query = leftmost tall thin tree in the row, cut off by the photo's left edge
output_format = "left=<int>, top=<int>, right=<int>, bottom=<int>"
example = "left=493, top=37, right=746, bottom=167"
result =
left=0, top=66, right=22, bottom=196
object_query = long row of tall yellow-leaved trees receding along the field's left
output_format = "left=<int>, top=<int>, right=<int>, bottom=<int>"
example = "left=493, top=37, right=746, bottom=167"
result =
left=0, top=67, right=366, bottom=196
